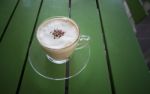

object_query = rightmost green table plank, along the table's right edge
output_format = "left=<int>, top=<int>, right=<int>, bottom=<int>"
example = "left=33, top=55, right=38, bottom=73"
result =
left=99, top=0, right=150, bottom=94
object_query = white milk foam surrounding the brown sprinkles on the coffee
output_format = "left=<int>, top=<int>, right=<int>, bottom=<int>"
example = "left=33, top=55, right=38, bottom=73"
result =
left=37, top=18, right=79, bottom=49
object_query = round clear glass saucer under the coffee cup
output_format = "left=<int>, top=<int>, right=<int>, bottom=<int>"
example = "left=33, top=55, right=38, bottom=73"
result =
left=28, top=38, right=90, bottom=80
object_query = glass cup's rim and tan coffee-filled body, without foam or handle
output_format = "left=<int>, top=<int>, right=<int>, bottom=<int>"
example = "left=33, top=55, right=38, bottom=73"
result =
left=37, top=17, right=80, bottom=64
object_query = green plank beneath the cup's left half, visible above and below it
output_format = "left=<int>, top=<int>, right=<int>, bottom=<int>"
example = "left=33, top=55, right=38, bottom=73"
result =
left=20, top=0, right=68, bottom=94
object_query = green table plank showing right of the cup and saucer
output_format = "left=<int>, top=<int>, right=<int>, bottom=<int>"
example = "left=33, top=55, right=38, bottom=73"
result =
left=69, top=0, right=111, bottom=94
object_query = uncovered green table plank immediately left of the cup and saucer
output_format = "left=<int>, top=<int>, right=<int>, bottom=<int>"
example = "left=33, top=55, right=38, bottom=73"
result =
left=0, top=0, right=40, bottom=94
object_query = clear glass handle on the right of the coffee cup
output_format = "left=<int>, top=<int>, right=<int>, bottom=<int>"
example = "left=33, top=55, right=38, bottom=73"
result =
left=75, top=35, right=90, bottom=50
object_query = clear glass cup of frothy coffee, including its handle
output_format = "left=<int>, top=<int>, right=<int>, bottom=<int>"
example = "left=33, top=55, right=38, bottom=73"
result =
left=36, top=16, right=89, bottom=64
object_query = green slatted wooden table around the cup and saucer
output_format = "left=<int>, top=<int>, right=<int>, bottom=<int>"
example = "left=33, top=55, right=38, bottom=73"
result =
left=0, top=0, right=150, bottom=94
